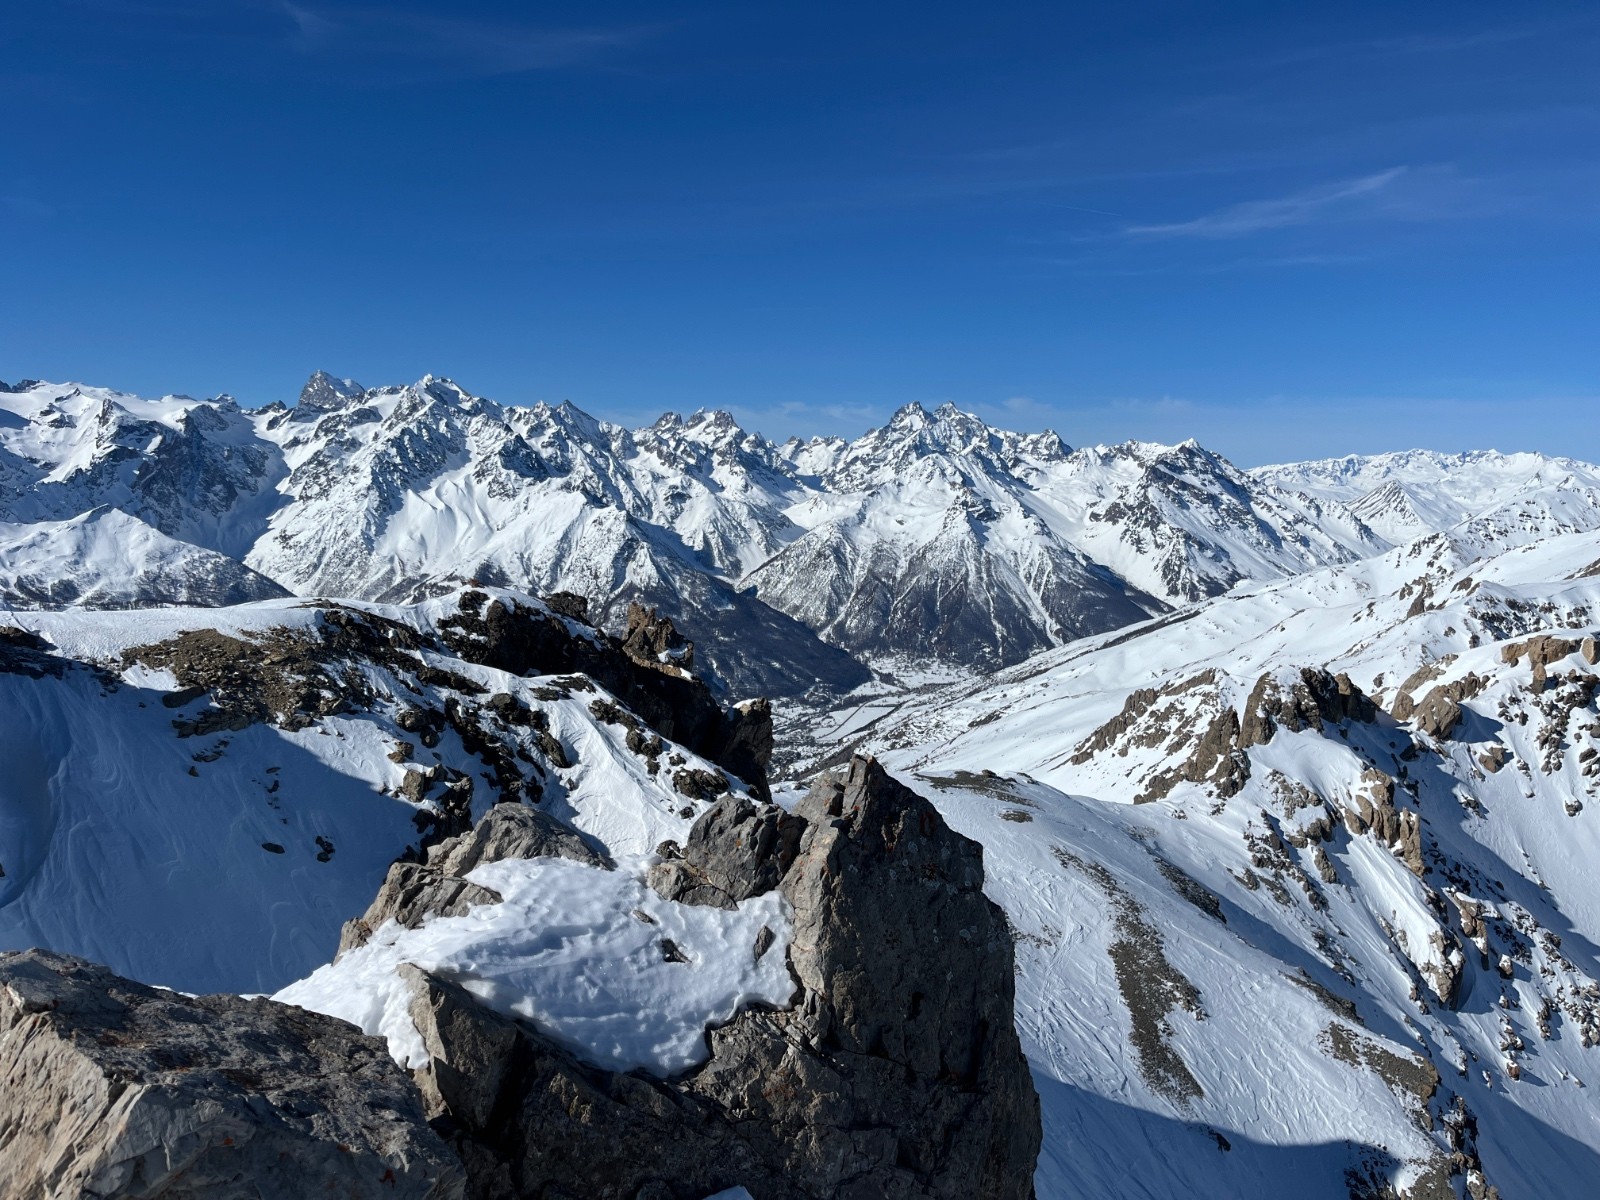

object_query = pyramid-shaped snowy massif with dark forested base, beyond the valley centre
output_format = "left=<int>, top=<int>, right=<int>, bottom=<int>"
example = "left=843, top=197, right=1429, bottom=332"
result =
left=747, top=405, right=1387, bottom=667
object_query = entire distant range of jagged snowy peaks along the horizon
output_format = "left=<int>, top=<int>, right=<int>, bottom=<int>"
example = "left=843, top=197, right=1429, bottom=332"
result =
left=0, top=371, right=1600, bottom=696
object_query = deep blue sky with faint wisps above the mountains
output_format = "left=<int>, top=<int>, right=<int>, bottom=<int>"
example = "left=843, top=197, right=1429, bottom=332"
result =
left=0, top=0, right=1600, bottom=464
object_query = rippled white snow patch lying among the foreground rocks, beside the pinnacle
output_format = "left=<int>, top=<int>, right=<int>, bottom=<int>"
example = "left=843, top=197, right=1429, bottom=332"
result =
left=274, top=858, right=794, bottom=1075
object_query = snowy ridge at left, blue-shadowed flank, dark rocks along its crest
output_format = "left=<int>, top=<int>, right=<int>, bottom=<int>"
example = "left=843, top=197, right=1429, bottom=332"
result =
left=0, top=592, right=774, bottom=992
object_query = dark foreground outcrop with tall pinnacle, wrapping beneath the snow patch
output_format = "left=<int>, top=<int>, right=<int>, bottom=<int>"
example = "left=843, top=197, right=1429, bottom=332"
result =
left=411, top=758, right=1040, bottom=1200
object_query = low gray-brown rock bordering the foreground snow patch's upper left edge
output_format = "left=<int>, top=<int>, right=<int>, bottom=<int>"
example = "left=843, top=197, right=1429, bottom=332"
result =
left=339, top=805, right=613, bottom=954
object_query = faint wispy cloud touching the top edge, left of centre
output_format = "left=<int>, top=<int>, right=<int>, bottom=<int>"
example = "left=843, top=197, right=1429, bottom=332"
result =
left=280, top=0, right=664, bottom=75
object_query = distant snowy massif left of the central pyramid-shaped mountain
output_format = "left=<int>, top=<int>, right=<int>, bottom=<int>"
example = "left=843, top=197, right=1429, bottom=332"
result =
left=0, top=373, right=866, bottom=694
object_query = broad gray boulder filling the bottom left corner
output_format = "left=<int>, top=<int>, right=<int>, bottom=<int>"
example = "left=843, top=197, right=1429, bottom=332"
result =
left=0, top=950, right=464, bottom=1200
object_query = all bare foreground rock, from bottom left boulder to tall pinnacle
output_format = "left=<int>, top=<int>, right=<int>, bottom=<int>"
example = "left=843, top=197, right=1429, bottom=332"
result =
left=0, top=758, right=1040, bottom=1200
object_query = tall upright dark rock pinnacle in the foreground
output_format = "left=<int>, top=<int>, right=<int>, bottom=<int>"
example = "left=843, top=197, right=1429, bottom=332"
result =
left=690, top=757, right=1042, bottom=1200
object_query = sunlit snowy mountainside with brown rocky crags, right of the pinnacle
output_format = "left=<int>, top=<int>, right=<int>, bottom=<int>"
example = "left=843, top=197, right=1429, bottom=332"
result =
left=825, top=526, right=1600, bottom=1200
